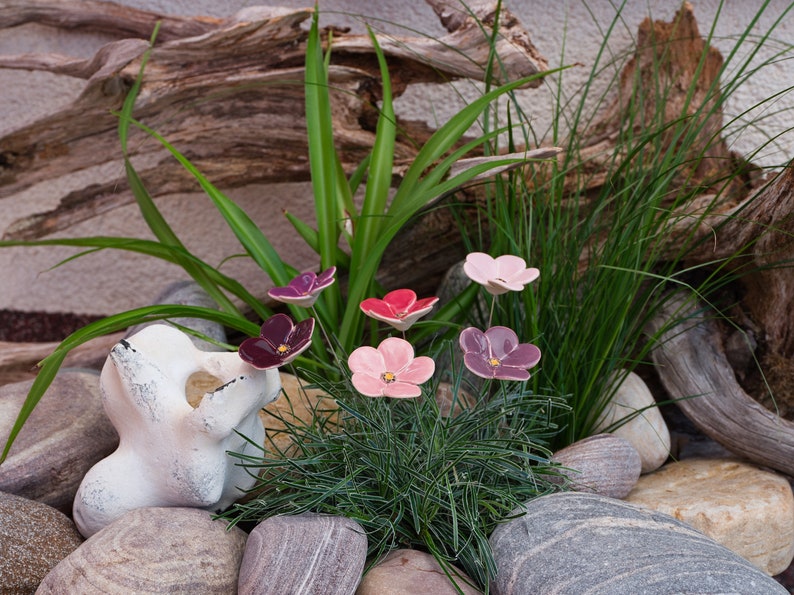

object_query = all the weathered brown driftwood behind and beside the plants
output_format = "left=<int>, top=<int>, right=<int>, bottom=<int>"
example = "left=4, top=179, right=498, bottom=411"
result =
left=0, top=0, right=794, bottom=475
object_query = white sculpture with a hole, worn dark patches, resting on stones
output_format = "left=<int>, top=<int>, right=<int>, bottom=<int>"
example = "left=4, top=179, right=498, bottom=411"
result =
left=73, top=324, right=281, bottom=537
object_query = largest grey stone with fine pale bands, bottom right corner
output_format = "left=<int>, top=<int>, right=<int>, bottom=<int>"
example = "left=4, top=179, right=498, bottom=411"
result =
left=490, top=492, right=787, bottom=595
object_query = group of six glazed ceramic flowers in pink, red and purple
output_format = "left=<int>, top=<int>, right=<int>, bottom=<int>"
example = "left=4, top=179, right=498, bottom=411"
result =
left=239, top=252, right=540, bottom=398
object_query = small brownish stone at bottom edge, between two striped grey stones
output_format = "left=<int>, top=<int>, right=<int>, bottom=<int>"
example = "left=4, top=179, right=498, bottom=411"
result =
left=356, top=550, right=481, bottom=595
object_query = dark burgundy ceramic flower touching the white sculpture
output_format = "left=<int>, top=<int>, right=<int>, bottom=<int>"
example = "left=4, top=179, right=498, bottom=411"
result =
left=238, top=314, right=314, bottom=370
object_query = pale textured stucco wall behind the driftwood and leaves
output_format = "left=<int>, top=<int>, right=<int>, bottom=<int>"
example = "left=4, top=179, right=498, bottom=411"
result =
left=0, top=0, right=794, bottom=313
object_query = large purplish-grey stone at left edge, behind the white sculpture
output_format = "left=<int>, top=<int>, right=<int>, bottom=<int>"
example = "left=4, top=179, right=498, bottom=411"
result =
left=0, top=369, right=118, bottom=513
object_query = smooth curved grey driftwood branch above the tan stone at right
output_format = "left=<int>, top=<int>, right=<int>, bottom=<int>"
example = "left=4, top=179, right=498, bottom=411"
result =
left=651, top=295, right=794, bottom=476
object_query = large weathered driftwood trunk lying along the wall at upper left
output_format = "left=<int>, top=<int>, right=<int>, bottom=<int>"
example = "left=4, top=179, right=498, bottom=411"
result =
left=0, top=0, right=547, bottom=239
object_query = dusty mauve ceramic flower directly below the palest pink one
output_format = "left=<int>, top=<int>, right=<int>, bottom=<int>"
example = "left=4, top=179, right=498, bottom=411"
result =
left=459, top=326, right=540, bottom=380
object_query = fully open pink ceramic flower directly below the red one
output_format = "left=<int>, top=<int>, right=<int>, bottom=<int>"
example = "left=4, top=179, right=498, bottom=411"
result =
left=347, top=337, right=436, bottom=398
